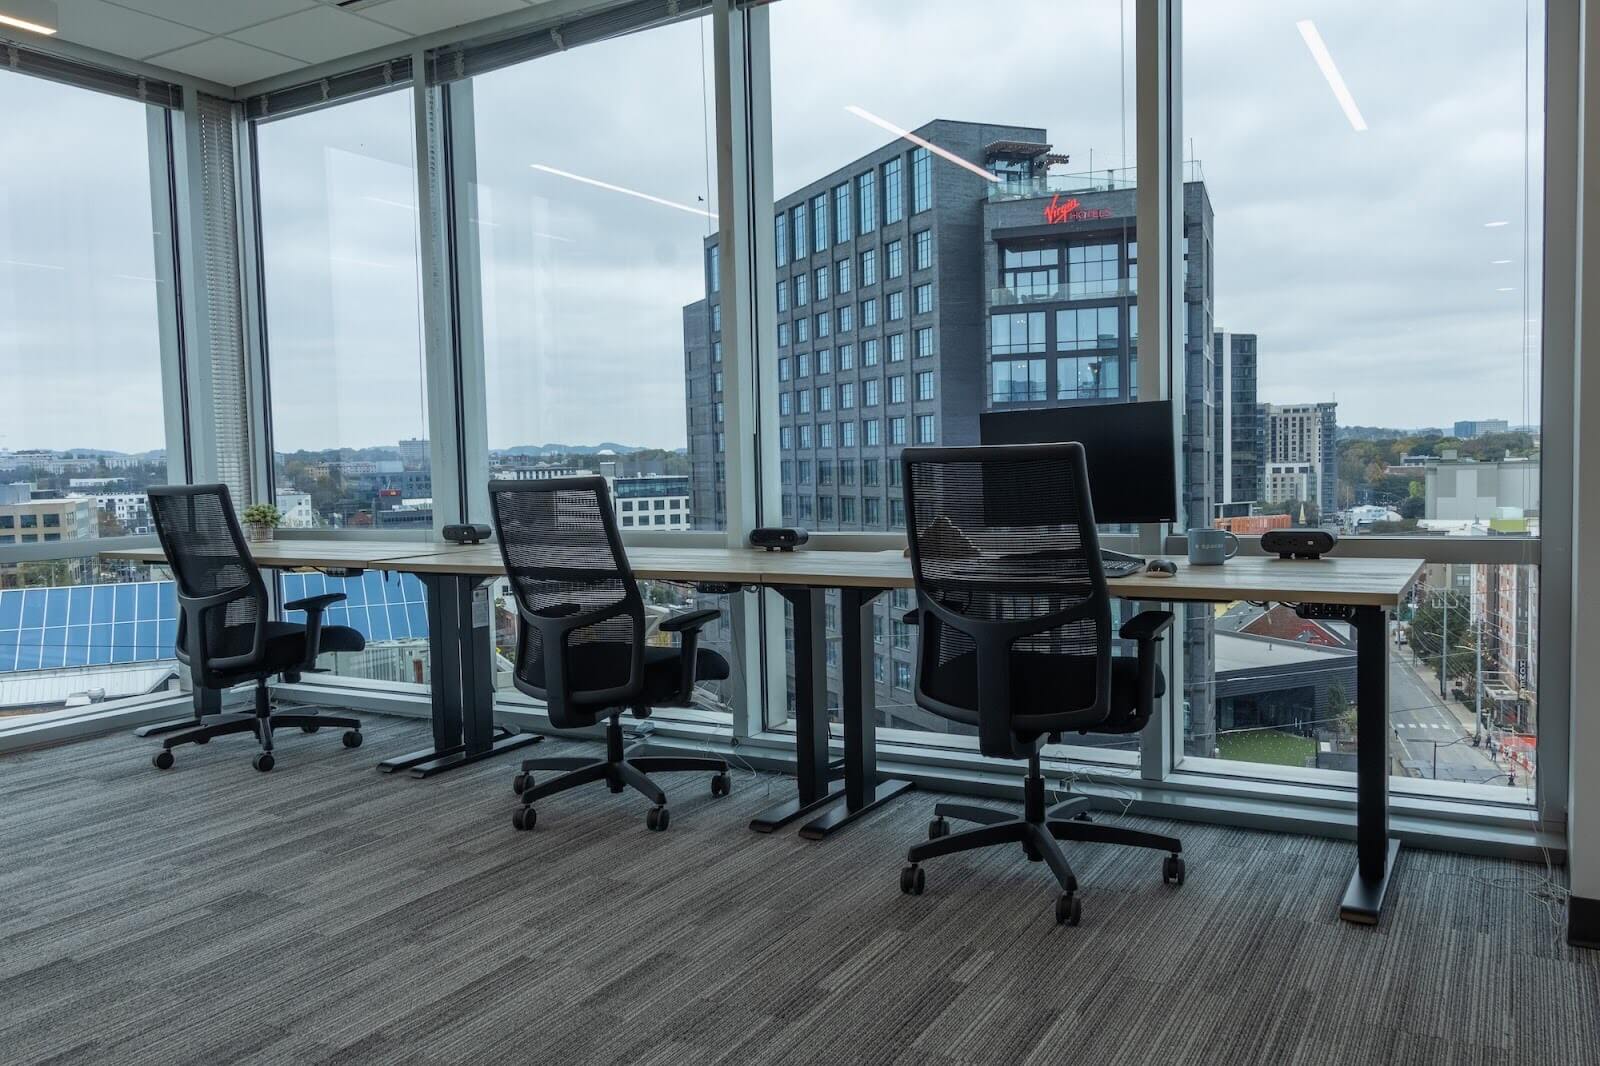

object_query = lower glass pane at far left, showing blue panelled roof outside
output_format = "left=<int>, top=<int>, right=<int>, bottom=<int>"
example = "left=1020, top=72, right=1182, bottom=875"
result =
left=0, top=555, right=178, bottom=723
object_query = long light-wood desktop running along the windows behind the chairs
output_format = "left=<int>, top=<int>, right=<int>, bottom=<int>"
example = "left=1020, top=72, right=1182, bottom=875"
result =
left=101, top=539, right=1422, bottom=607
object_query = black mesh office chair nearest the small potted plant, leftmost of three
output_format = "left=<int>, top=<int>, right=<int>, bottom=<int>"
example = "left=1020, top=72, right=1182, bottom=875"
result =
left=149, top=485, right=366, bottom=771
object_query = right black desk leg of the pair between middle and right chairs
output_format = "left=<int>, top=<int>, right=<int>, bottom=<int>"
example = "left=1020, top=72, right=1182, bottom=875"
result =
left=800, top=589, right=912, bottom=840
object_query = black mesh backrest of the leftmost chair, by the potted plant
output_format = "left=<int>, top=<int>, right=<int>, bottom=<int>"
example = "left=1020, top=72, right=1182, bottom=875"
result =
left=147, top=485, right=267, bottom=683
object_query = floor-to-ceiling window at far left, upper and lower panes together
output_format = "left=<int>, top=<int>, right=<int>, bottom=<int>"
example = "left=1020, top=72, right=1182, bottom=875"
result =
left=0, top=70, right=184, bottom=723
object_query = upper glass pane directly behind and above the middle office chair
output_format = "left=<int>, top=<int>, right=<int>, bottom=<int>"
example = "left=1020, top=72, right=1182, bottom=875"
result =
left=472, top=19, right=723, bottom=531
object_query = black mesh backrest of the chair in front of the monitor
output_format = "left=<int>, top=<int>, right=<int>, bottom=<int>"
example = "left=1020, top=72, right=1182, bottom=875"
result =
left=901, top=443, right=1112, bottom=757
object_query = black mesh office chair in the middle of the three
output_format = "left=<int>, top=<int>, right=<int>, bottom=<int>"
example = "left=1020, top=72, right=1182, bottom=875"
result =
left=490, top=477, right=731, bottom=829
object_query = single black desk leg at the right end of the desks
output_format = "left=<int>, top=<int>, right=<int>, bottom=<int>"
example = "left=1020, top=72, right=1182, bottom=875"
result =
left=1339, top=607, right=1400, bottom=925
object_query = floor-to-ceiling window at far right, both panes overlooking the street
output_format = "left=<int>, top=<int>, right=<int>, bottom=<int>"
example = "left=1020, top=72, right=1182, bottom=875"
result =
left=1181, top=0, right=1544, bottom=799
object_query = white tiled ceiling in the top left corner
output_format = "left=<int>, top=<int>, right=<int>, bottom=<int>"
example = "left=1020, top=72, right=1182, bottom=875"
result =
left=42, top=0, right=544, bottom=86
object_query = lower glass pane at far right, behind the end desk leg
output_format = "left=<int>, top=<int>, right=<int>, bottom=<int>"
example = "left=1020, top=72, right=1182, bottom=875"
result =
left=1184, top=563, right=1539, bottom=804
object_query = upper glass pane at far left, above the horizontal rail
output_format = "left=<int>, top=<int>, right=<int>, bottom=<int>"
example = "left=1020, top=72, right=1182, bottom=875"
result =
left=0, top=70, right=173, bottom=531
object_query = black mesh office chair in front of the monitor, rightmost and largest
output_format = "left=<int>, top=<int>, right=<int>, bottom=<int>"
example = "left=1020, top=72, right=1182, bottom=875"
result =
left=901, top=443, right=1184, bottom=925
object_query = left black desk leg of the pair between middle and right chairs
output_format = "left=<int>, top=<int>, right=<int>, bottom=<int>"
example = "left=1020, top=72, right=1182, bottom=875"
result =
left=750, top=587, right=843, bottom=832
